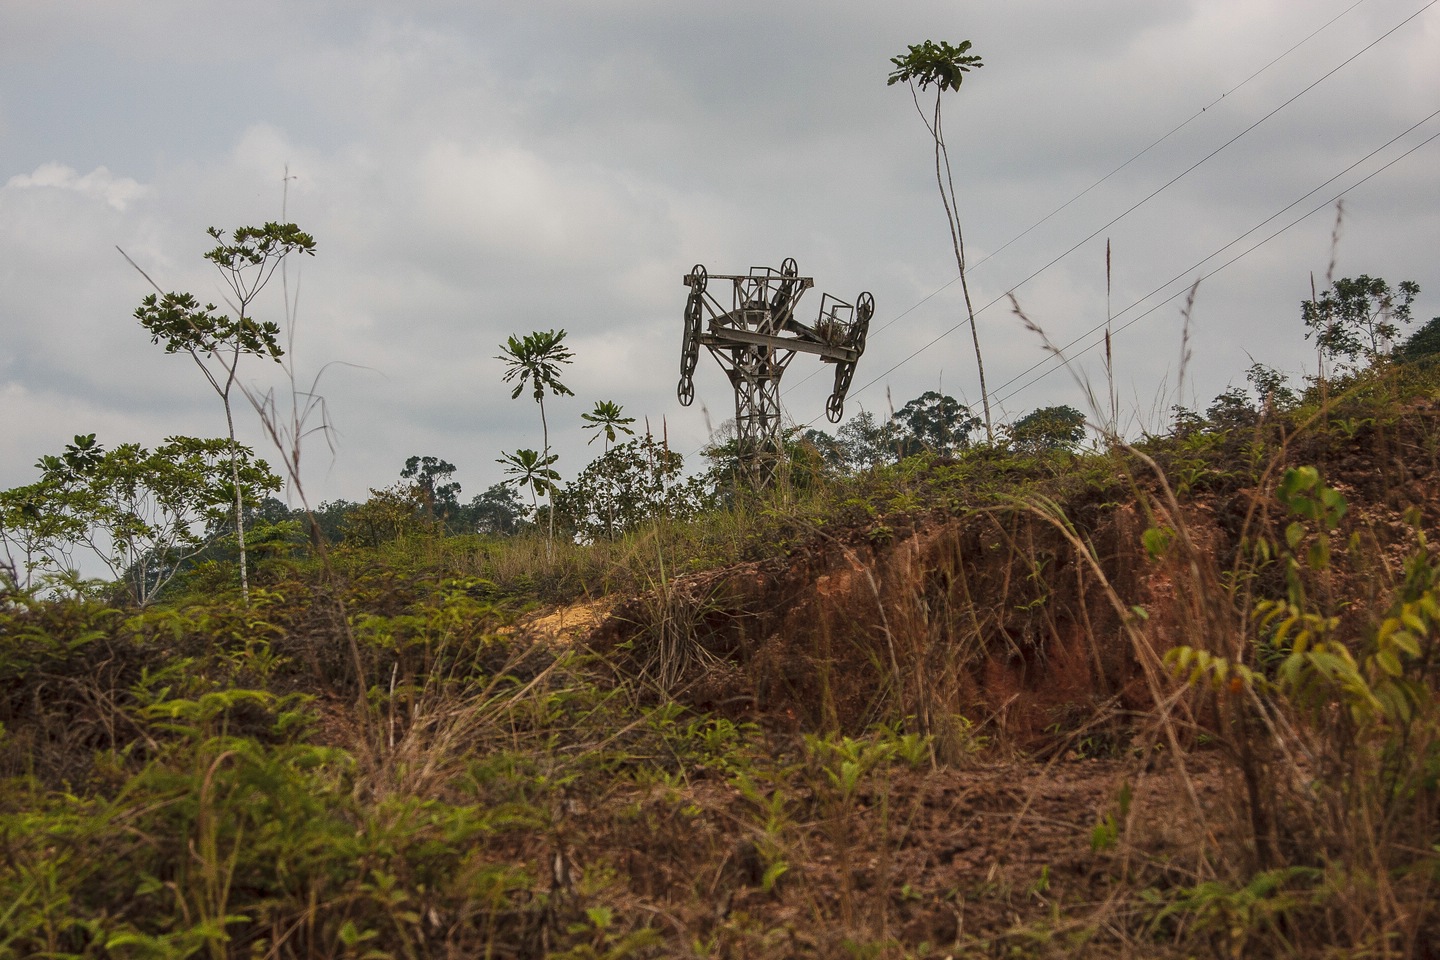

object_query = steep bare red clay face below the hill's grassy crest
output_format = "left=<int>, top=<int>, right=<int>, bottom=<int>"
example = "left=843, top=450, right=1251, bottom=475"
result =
left=590, top=495, right=1215, bottom=744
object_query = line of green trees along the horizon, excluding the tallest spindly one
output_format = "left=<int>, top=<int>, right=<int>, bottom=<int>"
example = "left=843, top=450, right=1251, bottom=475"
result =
left=0, top=208, right=1440, bottom=604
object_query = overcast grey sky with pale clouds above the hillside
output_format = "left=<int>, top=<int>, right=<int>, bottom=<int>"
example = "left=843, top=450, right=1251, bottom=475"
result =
left=0, top=0, right=1440, bottom=501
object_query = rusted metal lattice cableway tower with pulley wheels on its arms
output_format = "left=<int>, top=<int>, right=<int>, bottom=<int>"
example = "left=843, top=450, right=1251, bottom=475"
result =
left=677, top=258, right=876, bottom=489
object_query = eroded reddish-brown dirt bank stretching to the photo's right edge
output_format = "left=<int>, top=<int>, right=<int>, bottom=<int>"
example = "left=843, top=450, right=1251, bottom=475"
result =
left=590, top=407, right=1440, bottom=747
